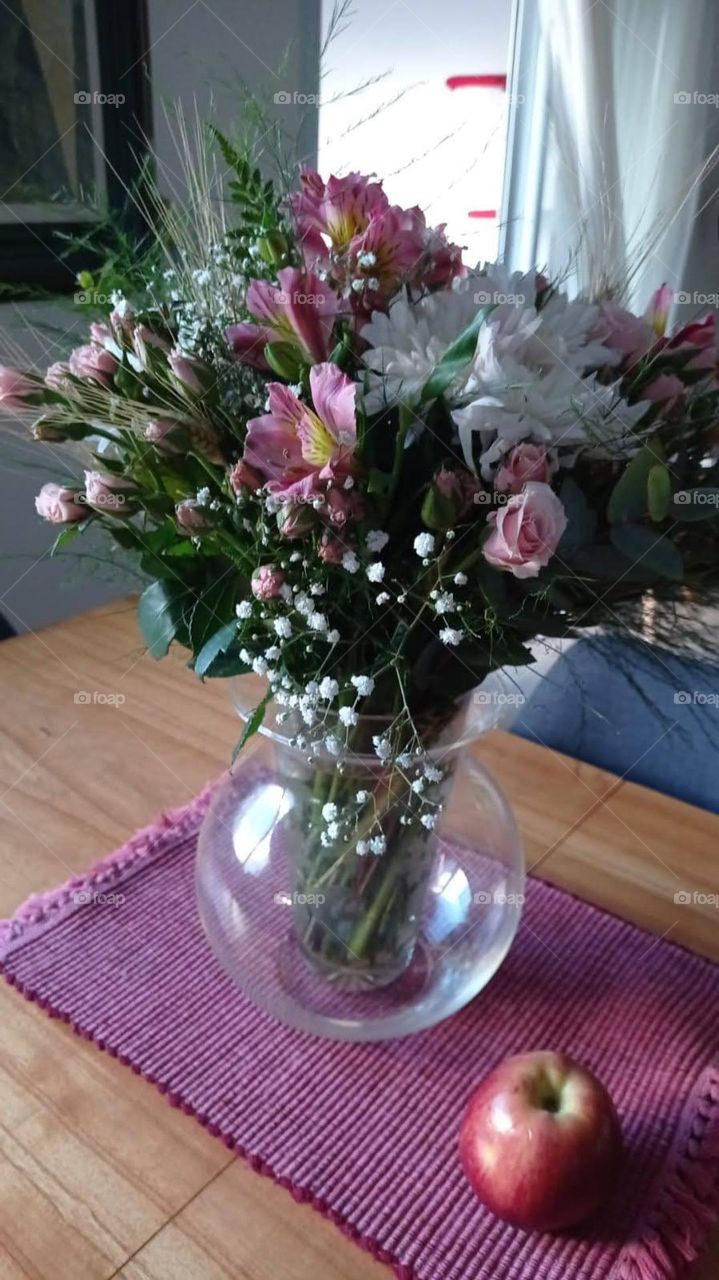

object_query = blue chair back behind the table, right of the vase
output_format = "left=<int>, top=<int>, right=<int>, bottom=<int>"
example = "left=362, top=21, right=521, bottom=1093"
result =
left=512, top=636, right=719, bottom=813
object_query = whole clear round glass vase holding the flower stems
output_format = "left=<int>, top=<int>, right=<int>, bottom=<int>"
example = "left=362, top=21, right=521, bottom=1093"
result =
left=196, top=691, right=525, bottom=1039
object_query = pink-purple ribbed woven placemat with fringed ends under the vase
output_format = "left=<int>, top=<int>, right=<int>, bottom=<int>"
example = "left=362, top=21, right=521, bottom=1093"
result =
left=0, top=792, right=719, bottom=1280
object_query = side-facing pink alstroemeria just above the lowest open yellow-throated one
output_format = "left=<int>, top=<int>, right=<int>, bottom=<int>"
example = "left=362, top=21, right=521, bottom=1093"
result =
left=225, top=266, right=339, bottom=369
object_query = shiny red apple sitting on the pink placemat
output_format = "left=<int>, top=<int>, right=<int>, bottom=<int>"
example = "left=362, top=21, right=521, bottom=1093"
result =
left=459, top=1052, right=622, bottom=1231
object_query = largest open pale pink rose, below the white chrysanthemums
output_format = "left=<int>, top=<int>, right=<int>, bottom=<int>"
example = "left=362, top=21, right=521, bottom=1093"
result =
left=482, top=480, right=567, bottom=577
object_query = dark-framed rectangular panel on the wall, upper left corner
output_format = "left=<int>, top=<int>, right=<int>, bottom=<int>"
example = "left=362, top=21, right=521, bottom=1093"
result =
left=0, top=0, right=148, bottom=292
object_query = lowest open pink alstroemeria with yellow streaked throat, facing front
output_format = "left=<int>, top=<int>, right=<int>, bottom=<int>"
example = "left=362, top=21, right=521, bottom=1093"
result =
left=243, top=365, right=357, bottom=499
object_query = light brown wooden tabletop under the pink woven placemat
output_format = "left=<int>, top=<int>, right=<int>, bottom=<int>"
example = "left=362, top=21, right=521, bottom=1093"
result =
left=0, top=602, right=719, bottom=1280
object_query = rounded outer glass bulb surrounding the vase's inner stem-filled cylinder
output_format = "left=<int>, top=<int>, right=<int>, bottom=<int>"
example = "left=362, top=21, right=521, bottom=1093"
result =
left=196, top=771, right=522, bottom=1041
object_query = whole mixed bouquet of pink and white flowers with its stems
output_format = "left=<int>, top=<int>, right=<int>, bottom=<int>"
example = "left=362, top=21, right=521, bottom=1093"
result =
left=8, top=138, right=719, bottom=1003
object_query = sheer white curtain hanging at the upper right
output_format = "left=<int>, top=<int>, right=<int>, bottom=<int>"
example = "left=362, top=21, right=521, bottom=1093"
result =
left=503, top=0, right=719, bottom=308
